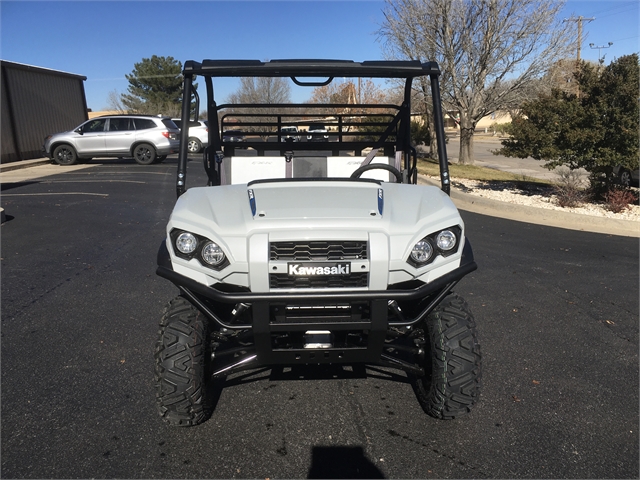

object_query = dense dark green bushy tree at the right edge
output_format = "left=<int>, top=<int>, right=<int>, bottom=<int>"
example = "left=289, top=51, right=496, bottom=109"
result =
left=496, top=54, right=640, bottom=187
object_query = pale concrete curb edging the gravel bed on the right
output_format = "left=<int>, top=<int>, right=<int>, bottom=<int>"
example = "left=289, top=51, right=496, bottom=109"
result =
left=419, top=175, right=640, bottom=237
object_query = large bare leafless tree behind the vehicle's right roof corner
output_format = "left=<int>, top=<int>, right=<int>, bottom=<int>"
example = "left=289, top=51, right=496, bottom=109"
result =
left=378, top=0, right=572, bottom=163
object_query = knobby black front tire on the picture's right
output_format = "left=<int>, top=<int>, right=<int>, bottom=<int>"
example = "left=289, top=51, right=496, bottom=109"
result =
left=411, top=294, right=482, bottom=419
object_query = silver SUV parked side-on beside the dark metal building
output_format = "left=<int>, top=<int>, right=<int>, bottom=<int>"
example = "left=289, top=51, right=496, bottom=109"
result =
left=42, top=115, right=180, bottom=165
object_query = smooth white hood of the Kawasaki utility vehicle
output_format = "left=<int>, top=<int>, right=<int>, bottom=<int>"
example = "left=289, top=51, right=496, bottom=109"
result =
left=170, top=181, right=460, bottom=237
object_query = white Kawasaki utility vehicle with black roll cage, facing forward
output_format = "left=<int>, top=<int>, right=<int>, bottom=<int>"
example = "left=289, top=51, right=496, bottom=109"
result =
left=155, top=60, right=481, bottom=426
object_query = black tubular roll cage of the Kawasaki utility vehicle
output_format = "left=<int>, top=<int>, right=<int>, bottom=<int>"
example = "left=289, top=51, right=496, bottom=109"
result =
left=176, top=60, right=450, bottom=197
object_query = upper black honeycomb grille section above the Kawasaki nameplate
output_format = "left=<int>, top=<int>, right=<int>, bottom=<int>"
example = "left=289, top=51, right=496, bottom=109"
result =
left=269, top=241, right=367, bottom=261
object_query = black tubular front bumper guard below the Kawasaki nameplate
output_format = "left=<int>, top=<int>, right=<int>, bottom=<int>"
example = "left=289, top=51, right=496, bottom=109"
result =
left=156, top=241, right=477, bottom=367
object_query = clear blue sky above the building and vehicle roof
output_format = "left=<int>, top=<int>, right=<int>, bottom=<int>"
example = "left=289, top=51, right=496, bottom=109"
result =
left=0, top=0, right=640, bottom=111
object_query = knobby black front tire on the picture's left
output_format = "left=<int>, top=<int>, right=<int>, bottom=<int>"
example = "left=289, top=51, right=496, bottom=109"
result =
left=155, top=297, right=213, bottom=427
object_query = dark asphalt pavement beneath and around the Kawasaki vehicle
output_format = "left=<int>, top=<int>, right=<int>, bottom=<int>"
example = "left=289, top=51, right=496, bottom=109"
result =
left=0, top=158, right=640, bottom=478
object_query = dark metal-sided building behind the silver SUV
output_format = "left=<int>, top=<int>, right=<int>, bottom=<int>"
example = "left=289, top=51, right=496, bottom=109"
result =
left=0, top=60, right=87, bottom=163
